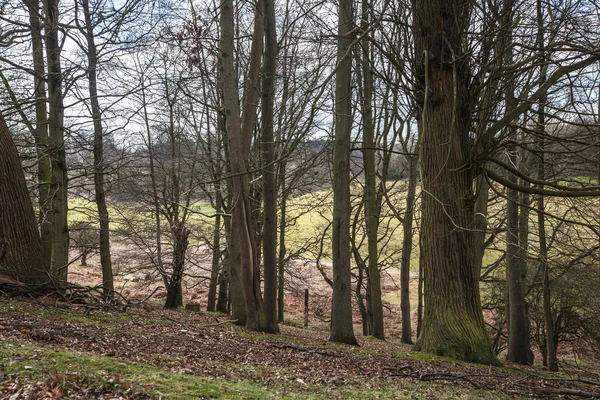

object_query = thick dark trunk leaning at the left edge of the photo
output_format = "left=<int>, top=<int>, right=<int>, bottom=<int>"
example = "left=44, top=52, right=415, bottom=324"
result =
left=0, top=114, right=49, bottom=285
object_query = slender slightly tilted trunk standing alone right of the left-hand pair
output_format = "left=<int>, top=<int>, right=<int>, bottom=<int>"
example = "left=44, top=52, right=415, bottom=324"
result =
left=81, top=0, right=115, bottom=300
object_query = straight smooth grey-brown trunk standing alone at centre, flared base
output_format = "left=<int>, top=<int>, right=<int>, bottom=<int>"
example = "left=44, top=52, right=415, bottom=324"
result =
left=330, top=0, right=357, bottom=345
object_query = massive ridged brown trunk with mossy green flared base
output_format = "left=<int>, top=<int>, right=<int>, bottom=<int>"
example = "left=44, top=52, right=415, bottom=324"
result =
left=413, top=0, right=499, bottom=364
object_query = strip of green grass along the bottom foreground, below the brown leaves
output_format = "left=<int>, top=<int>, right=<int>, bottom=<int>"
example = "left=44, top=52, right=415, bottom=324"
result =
left=0, top=340, right=492, bottom=400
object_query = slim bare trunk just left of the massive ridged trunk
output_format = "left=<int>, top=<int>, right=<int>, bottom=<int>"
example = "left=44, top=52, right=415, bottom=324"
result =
left=400, top=156, right=418, bottom=343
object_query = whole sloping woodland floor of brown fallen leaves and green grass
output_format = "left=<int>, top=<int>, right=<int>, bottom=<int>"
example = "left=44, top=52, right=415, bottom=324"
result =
left=0, top=296, right=600, bottom=400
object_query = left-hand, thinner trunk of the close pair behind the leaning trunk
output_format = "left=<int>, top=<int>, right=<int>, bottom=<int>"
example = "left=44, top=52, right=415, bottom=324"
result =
left=25, top=0, right=54, bottom=260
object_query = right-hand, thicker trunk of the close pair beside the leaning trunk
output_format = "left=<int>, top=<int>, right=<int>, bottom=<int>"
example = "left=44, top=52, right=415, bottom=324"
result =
left=44, top=0, right=69, bottom=286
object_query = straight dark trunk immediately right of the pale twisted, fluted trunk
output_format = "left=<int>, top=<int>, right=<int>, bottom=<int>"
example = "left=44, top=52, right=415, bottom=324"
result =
left=261, top=0, right=279, bottom=332
